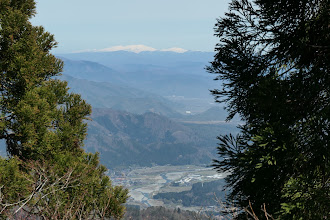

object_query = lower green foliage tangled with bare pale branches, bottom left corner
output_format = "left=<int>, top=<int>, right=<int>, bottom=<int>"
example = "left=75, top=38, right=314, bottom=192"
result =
left=0, top=154, right=128, bottom=219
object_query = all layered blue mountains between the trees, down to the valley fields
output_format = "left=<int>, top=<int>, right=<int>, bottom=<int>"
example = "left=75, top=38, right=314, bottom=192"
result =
left=59, top=48, right=236, bottom=167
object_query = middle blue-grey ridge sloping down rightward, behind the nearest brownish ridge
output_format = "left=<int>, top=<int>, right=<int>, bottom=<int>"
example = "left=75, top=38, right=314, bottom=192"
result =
left=59, top=74, right=180, bottom=117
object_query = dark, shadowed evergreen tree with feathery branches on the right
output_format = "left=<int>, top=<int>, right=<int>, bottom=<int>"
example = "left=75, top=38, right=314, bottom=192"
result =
left=207, top=0, right=330, bottom=219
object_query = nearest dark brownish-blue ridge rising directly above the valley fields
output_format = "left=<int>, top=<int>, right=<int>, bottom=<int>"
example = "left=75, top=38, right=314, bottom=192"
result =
left=85, top=109, right=214, bottom=168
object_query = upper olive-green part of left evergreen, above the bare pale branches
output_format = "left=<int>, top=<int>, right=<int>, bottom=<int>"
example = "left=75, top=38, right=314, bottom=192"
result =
left=0, top=1, right=86, bottom=159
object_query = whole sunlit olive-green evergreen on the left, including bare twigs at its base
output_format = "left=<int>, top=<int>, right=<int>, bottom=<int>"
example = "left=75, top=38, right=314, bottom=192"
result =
left=0, top=0, right=128, bottom=219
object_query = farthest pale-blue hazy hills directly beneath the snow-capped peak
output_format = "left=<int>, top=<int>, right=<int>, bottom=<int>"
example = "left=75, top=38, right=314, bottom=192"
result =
left=59, top=51, right=218, bottom=100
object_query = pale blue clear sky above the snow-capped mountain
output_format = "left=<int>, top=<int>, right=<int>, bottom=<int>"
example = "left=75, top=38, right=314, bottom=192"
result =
left=32, top=0, right=229, bottom=53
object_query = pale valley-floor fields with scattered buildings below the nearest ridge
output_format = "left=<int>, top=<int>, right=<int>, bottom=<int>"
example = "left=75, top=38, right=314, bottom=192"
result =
left=110, top=165, right=225, bottom=211
